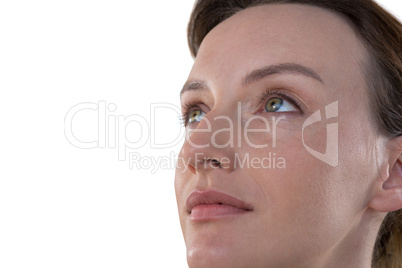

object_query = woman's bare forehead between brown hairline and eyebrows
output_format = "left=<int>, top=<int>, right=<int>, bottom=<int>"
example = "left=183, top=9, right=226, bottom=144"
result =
left=190, top=4, right=365, bottom=89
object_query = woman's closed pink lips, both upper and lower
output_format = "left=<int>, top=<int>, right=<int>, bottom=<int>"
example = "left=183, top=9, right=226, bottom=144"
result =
left=186, top=189, right=253, bottom=221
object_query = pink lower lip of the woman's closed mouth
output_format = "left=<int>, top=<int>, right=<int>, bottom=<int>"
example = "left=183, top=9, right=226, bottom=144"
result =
left=190, top=204, right=250, bottom=221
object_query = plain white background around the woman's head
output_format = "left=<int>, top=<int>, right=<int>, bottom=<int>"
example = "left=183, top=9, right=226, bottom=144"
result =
left=0, top=0, right=402, bottom=268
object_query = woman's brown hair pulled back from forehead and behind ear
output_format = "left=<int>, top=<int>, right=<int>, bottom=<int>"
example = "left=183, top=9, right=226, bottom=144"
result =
left=187, top=0, right=402, bottom=268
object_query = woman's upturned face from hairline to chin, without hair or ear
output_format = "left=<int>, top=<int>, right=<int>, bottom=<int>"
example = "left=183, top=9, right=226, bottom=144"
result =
left=175, top=5, right=378, bottom=267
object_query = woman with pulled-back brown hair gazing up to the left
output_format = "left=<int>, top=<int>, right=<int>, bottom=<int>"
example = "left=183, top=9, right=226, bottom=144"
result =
left=175, top=0, right=402, bottom=268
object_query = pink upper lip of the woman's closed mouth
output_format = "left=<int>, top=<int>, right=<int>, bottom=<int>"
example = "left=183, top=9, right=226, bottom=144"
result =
left=186, top=190, right=253, bottom=212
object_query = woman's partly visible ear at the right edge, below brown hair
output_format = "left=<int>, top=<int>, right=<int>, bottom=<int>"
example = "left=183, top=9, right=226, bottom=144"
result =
left=369, top=136, right=402, bottom=212
